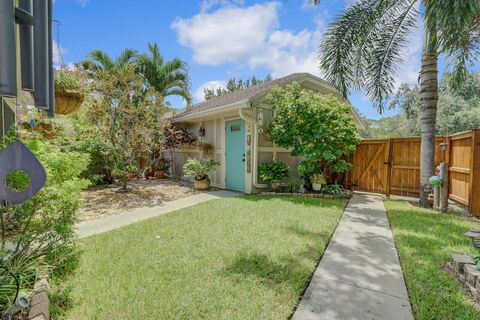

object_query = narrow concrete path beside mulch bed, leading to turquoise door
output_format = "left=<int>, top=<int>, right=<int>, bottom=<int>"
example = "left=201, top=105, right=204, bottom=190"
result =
left=75, top=190, right=239, bottom=238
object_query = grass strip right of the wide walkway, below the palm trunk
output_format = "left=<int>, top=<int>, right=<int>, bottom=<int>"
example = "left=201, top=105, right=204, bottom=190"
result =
left=385, top=200, right=480, bottom=320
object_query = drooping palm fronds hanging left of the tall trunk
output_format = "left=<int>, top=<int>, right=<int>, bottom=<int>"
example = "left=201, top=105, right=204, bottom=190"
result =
left=319, top=0, right=418, bottom=112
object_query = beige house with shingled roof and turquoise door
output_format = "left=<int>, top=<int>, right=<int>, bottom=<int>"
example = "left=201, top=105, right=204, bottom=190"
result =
left=171, top=73, right=363, bottom=193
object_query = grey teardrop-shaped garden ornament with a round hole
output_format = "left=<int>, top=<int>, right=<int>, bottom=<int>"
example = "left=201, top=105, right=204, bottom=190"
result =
left=0, top=140, right=47, bottom=204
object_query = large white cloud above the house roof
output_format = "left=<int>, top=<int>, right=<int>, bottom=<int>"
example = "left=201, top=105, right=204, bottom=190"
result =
left=172, top=0, right=324, bottom=77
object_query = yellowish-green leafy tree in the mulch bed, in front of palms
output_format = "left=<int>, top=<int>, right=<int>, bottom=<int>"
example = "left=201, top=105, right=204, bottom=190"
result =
left=83, top=66, right=164, bottom=191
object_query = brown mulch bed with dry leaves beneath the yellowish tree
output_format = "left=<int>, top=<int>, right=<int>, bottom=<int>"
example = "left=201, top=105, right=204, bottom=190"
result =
left=78, top=179, right=195, bottom=221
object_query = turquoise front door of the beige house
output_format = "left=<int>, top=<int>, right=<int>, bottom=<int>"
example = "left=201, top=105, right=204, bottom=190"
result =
left=225, top=119, right=245, bottom=191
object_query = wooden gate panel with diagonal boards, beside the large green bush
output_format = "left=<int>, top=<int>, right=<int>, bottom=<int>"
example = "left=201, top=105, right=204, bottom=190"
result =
left=352, top=140, right=390, bottom=193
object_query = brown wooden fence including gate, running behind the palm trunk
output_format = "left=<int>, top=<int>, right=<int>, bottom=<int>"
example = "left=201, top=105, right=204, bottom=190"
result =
left=346, top=129, right=480, bottom=216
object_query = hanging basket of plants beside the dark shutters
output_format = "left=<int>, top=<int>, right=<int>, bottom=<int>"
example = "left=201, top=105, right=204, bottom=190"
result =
left=55, top=68, right=87, bottom=114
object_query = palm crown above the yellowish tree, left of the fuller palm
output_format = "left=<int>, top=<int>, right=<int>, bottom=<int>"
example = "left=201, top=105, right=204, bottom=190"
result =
left=80, top=48, right=138, bottom=74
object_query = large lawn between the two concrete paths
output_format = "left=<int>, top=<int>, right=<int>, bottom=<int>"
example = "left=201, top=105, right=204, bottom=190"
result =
left=57, top=196, right=345, bottom=319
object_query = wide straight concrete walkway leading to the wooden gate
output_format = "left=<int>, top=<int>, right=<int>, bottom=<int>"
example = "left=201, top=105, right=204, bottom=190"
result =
left=293, top=195, right=413, bottom=320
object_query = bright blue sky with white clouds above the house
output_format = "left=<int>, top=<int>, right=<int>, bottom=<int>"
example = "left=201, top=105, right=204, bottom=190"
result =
left=54, top=0, right=479, bottom=118
